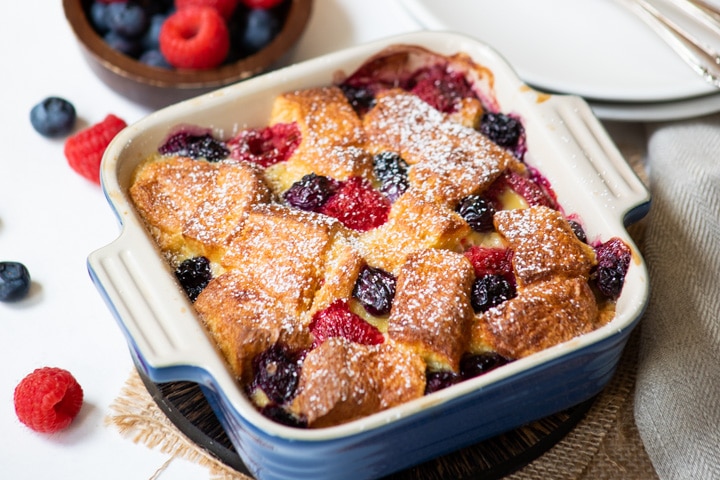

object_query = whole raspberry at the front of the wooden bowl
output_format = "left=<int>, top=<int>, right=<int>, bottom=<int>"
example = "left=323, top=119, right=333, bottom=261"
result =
left=159, top=6, right=230, bottom=69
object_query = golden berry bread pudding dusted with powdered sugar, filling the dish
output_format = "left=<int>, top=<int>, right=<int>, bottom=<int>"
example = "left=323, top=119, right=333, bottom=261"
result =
left=129, top=46, right=631, bottom=428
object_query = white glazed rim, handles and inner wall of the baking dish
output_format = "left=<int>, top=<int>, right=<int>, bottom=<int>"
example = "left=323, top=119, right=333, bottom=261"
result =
left=88, top=32, right=649, bottom=464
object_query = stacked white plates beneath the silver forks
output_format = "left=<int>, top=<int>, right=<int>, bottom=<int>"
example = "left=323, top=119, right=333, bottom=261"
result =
left=400, top=0, right=720, bottom=121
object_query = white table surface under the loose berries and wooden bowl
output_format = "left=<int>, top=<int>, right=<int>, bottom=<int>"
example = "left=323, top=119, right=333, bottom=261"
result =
left=0, top=0, right=648, bottom=480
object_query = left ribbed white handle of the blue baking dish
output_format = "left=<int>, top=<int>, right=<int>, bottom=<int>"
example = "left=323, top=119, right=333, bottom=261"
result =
left=87, top=228, right=224, bottom=382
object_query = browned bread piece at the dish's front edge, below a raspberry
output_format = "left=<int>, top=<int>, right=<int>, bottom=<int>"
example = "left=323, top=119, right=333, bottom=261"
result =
left=291, top=337, right=425, bottom=427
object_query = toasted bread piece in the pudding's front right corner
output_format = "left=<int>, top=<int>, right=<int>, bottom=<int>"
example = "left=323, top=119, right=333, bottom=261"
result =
left=470, top=277, right=598, bottom=359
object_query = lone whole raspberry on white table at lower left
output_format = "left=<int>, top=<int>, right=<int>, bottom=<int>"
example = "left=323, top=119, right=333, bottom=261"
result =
left=14, top=367, right=83, bottom=433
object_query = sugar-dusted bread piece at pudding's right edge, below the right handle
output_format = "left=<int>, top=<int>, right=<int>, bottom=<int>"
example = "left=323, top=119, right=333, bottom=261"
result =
left=493, top=206, right=596, bottom=287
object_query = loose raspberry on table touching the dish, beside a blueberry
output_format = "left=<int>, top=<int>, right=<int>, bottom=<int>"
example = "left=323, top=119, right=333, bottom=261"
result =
left=65, top=114, right=127, bottom=184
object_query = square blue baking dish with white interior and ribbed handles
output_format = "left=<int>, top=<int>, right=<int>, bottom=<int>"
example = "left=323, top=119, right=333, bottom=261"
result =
left=88, top=32, right=650, bottom=479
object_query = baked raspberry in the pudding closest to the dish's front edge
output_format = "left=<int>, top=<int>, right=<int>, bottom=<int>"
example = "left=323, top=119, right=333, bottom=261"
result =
left=310, top=299, right=385, bottom=348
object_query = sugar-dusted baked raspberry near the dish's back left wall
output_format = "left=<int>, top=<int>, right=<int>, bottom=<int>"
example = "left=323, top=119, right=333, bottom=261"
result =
left=228, top=123, right=301, bottom=167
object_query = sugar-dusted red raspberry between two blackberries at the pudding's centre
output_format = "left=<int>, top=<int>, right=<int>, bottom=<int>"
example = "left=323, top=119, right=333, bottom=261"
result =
left=320, top=177, right=390, bottom=231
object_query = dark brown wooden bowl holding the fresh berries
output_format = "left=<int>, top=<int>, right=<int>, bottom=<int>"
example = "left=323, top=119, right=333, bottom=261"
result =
left=63, top=0, right=313, bottom=108
